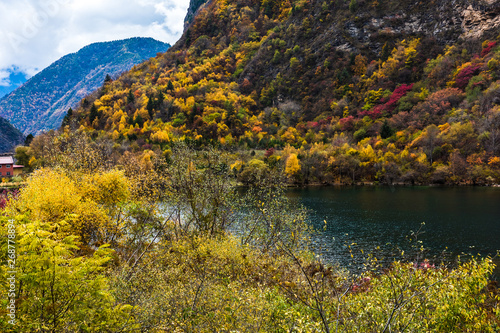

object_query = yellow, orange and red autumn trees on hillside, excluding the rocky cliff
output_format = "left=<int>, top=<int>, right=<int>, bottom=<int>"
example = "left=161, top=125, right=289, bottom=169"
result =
left=31, top=1, right=500, bottom=184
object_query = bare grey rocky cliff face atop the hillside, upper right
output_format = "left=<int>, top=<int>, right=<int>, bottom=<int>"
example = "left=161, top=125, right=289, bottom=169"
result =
left=284, top=0, right=500, bottom=53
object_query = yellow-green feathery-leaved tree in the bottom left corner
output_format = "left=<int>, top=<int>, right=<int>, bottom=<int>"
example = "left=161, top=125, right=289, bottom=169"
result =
left=0, top=217, right=132, bottom=333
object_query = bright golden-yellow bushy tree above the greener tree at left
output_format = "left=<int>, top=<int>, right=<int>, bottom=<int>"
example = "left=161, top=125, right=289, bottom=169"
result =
left=8, top=168, right=130, bottom=245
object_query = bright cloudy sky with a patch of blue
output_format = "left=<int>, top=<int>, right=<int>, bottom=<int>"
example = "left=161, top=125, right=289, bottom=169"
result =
left=0, top=0, right=189, bottom=86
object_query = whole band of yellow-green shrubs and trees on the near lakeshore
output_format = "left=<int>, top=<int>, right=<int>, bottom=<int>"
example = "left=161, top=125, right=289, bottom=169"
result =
left=0, top=132, right=500, bottom=332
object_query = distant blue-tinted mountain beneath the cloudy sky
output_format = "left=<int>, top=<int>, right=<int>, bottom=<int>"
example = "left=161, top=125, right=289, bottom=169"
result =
left=0, top=38, right=170, bottom=134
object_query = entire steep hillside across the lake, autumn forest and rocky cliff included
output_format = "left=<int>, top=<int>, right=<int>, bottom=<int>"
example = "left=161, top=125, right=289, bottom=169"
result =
left=60, top=0, right=500, bottom=184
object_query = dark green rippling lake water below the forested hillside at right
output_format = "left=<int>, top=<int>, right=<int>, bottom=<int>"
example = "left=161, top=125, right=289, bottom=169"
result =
left=288, top=187, right=500, bottom=280
